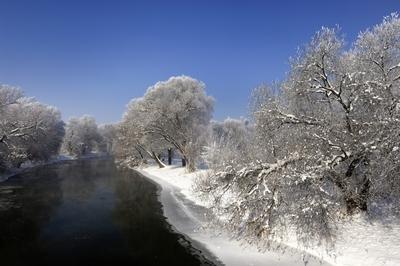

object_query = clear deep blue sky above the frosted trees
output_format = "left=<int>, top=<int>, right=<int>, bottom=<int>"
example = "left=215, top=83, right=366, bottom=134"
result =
left=0, top=0, right=400, bottom=123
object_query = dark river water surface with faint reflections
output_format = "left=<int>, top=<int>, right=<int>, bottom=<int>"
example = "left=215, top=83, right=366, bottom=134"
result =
left=0, top=159, right=217, bottom=266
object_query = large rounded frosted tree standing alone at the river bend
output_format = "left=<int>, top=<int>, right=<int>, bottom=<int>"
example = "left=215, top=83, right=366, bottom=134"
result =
left=117, top=76, right=214, bottom=171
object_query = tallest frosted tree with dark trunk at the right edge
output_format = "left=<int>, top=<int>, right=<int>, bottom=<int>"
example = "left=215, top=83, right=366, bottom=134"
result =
left=274, top=15, right=400, bottom=213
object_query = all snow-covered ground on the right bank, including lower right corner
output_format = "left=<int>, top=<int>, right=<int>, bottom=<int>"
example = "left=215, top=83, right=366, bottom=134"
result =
left=139, top=166, right=400, bottom=266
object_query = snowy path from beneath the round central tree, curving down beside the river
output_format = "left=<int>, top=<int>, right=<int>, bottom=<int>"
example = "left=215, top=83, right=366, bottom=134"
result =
left=139, top=167, right=329, bottom=266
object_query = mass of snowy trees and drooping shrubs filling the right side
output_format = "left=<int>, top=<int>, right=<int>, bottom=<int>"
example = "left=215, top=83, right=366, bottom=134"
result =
left=198, top=14, right=400, bottom=249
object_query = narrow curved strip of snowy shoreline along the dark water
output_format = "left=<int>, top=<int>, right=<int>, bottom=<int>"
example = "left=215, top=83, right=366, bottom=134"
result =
left=134, top=168, right=330, bottom=266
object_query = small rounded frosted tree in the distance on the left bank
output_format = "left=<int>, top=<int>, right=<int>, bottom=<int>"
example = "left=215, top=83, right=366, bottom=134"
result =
left=63, top=115, right=101, bottom=156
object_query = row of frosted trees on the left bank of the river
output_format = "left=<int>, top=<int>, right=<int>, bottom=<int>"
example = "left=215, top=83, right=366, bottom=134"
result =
left=0, top=85, right=115, bottom=172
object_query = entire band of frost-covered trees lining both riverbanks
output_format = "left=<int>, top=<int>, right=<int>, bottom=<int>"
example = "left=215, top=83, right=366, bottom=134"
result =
left=0, top=14, right=400, bottom=254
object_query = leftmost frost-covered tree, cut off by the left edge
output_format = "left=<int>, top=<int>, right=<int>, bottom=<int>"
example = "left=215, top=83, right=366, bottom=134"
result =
left=0, top=85, right=64, bottom=168
